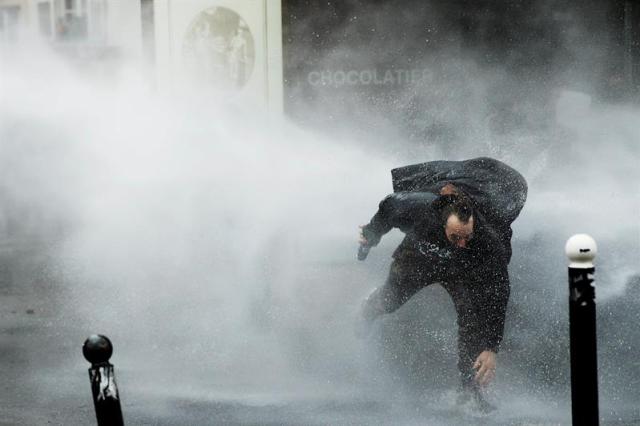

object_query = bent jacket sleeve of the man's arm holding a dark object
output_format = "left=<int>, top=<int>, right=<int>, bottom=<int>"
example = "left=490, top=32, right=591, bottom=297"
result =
left=362, top=192, right=438, bottom=246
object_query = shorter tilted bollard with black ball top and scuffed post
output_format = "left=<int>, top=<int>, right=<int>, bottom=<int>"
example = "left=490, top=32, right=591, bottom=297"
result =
left=82, top=334, right=124, bottom=426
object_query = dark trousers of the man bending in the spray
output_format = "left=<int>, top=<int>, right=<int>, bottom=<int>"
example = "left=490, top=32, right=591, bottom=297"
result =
left=363, top=260, right=486, bottom=386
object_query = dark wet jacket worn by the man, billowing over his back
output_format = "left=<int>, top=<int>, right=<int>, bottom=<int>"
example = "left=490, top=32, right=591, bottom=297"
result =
left=363, top=158, right=527, bottom=352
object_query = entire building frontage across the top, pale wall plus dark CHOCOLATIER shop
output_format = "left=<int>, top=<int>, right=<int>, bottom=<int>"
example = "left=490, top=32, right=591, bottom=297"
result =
left=0, top=0, right=640, bottom=136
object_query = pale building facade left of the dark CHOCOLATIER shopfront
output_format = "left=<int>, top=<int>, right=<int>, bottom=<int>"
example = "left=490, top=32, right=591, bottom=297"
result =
left=0, top=0, right=283, bottom=110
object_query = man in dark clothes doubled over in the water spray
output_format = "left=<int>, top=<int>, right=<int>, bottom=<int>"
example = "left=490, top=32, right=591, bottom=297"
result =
left=360, top=158, right=526, bottom=411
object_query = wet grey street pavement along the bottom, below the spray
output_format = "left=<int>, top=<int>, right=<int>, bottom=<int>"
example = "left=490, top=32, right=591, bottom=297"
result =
left=0, top=235, right=640, bottom=426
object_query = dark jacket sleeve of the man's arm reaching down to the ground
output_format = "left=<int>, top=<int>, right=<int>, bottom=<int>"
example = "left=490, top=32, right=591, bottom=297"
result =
left=478, top=262, right=511, bottom=353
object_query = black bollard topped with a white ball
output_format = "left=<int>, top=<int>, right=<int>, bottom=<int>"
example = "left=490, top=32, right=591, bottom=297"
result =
left=565, top=234, right=599, bottom=426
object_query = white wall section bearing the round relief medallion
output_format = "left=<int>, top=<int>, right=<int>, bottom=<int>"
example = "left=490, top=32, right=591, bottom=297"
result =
left=155, top=0, right=283, bottom=111
